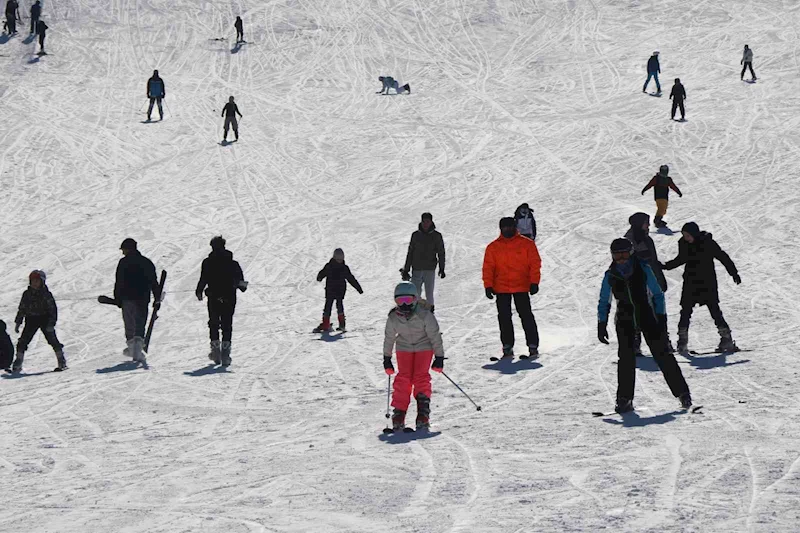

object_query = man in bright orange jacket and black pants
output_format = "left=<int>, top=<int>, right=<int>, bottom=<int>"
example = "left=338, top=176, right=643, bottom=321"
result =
left=483, top=217, right=542, bottom=358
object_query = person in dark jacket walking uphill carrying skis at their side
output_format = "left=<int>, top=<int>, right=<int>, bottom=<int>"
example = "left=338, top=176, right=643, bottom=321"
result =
left=114, top=237, right=161, bottom=363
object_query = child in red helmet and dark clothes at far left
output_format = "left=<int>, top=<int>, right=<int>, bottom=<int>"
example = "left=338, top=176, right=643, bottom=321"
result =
left=12, top=270, right=67, bottom=372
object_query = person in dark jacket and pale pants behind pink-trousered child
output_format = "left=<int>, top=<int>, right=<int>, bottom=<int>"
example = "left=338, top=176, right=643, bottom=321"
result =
left=400, top=213, right=446, bottom=313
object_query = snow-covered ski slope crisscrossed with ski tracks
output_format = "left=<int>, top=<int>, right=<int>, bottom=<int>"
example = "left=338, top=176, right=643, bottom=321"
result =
left=0, top=0, right=800, bottom=533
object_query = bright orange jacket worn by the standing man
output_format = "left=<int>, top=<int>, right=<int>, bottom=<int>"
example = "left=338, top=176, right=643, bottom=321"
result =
left=483, top=233, right=542, bottom=294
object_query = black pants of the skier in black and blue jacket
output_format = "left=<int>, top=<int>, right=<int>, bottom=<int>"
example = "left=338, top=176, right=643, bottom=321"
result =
left=615, top=315, right=689, bottom=401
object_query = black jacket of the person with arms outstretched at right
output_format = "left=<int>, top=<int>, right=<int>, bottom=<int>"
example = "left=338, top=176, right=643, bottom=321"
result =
left=664, top=231, right=737, bottom=307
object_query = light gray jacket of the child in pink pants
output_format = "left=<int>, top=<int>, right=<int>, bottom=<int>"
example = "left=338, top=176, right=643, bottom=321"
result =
left=383, top=304, right=444, bottom=357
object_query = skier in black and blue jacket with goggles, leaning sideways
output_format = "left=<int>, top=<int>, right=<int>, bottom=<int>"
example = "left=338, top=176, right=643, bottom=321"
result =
left=597, top=239, right=692, bottom=413
